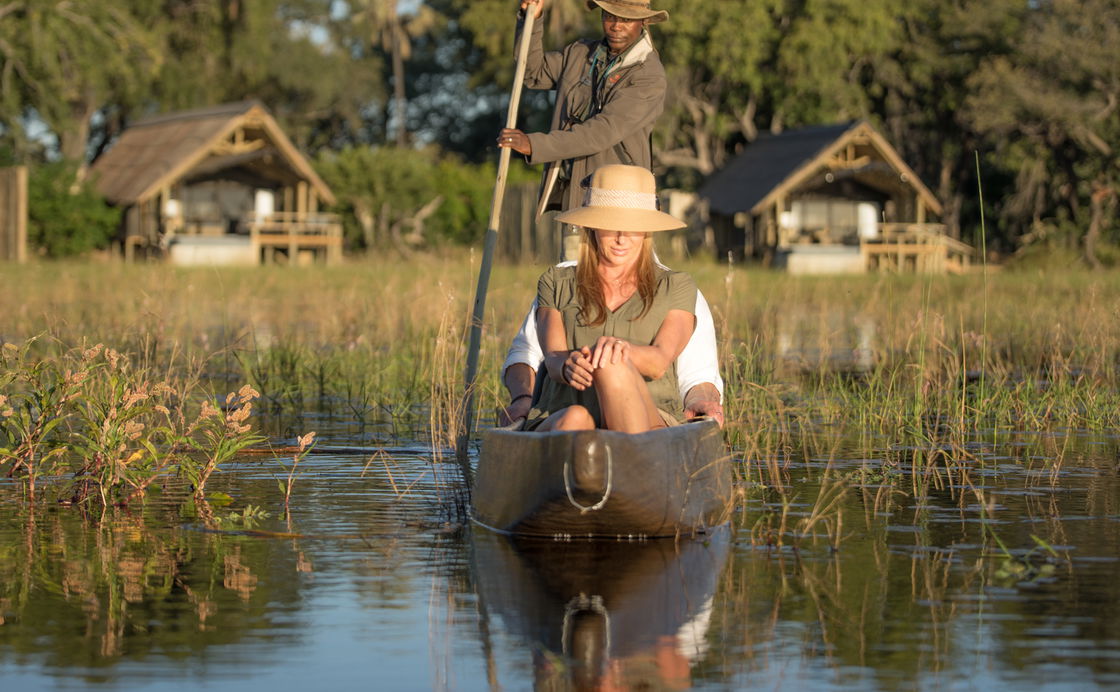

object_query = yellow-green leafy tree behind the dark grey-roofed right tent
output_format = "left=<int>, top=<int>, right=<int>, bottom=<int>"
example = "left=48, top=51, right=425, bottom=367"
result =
left=655, top=0, right=903, bottom=183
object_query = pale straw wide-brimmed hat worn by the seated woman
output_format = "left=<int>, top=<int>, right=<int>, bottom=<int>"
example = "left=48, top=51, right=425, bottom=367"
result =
left=557, top=163, right=685, bottom=233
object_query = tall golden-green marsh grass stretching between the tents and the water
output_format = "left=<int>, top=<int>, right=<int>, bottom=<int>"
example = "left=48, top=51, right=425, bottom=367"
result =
left=0, top=254, right=1120, bottom=530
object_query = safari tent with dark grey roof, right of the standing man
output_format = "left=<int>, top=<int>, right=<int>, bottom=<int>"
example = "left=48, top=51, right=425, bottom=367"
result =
left=699, top=121, right=972, bottom=273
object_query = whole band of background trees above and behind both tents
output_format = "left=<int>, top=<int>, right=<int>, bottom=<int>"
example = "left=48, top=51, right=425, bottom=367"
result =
left=0, top=0, right=1120, bottom=259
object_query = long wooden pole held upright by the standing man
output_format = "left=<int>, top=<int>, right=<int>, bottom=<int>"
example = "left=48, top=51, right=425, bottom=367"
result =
left=455, top=5, right=536, bottom=481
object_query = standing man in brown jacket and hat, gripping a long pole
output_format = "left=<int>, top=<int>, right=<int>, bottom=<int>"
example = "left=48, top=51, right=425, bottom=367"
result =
left=497, top=0, right=669, bottom=259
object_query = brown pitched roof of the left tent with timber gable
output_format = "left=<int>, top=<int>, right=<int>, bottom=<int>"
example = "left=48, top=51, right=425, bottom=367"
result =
left=92, top=101, right=335, bottom=206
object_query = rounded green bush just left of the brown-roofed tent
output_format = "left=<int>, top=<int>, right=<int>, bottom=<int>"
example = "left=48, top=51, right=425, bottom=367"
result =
left=27, top=161, right=121, bottom=258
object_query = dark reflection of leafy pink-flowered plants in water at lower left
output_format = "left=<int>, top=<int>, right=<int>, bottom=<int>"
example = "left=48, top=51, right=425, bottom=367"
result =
left=0, top=492, right=311, bottom=668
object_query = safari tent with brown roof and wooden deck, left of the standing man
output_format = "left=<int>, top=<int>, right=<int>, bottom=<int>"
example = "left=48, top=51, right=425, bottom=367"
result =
left=92, top=102, right=342, bottom=264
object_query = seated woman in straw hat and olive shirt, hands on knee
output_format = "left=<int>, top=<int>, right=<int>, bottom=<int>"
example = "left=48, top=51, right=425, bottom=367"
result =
left=524, top=165, right=697, bottom=432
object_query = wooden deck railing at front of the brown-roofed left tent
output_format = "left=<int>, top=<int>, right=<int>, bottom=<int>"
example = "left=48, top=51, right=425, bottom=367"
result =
left=244, top=212, right=343, bottom=264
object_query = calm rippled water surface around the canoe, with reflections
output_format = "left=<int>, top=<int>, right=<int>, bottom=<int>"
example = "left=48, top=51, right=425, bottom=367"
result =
left=0, top=431, right=1120, bottom=691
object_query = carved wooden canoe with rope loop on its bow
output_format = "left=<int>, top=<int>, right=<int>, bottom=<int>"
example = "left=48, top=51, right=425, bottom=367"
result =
left=472, top=419, right=732, bottom=539
